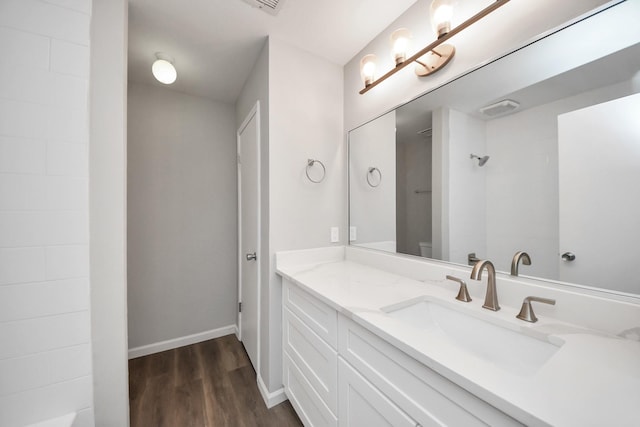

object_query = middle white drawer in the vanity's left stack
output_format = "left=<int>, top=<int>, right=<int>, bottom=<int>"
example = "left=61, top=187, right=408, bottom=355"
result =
left=283, top=307, right=338, bottom=414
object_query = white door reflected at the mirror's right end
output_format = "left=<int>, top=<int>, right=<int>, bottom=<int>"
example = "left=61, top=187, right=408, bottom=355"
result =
left=558, top=94, right=640, bottom=293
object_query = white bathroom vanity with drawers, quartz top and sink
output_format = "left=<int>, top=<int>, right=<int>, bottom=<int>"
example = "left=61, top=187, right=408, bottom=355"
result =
left=277, top=247, right=640, bottom=426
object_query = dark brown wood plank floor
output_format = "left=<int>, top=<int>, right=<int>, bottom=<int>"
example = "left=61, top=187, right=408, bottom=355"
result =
left=129, top=335, right=302, bottom=427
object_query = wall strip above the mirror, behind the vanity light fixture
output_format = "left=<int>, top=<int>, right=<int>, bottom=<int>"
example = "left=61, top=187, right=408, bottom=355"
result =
left=344, top=0, right=608, bottom=130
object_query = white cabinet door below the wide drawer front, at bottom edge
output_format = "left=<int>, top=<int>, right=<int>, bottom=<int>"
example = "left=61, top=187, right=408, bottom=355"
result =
left=338, top=358, right=417, bottom=427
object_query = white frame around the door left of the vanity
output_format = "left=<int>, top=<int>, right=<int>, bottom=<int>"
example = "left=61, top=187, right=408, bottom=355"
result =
left=236, top=100, right=262, bottom=376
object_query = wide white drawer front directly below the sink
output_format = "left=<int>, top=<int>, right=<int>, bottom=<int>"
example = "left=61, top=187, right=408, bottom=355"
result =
left=338, top=316, right=521, bottom=427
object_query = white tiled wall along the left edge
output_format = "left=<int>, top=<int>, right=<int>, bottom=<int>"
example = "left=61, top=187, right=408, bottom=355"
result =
left=0, top=0, right=93, bottom=426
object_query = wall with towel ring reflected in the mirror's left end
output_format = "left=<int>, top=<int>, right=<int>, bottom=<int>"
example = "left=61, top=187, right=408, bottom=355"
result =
left=345, top=111, right=396, bottom=247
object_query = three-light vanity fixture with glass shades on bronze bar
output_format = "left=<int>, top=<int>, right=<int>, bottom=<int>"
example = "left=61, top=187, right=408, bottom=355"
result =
left=360, top=0, right=509, bottom=95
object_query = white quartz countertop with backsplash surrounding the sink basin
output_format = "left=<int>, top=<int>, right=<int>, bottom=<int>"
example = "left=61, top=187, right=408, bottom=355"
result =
left=277, top=260, right=640, bottom=427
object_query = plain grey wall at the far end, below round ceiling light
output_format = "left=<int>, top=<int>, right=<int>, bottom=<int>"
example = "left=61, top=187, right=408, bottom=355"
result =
left=127, top=82, right=237, bottom=350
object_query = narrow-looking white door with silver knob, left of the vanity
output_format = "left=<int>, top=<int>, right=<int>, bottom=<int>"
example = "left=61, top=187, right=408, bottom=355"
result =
left=238, top=103, right=261, bottom=372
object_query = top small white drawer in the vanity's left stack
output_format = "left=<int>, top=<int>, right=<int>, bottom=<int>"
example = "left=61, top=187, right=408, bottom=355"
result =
left=282, top=279, right=338, bottom=349
